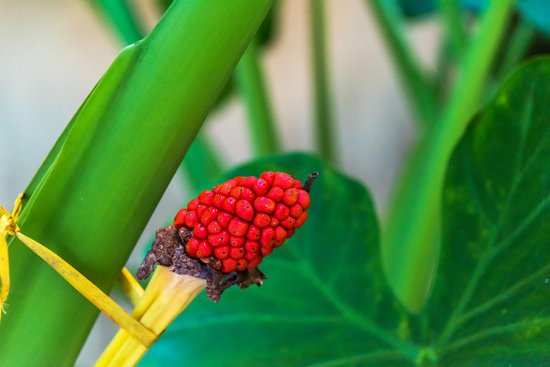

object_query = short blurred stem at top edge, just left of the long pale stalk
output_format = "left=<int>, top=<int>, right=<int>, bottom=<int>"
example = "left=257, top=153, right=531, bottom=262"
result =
left=437, top=0, right=468, bottom=56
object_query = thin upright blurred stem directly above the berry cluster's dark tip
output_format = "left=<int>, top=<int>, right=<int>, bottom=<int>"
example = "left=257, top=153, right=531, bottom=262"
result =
left=310, top=0, right=336, bottom=161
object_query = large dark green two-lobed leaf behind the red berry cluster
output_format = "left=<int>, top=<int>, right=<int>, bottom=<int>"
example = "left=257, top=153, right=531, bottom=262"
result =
left=143, top=59, right=550, bottom=367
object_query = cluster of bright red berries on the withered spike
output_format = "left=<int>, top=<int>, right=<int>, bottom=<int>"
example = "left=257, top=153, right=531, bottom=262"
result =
left=174, top=172, right=310, bottom=273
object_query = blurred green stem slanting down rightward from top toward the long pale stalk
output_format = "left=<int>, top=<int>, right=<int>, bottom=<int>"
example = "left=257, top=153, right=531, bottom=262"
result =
left=367, top=0, right=436, bottom=126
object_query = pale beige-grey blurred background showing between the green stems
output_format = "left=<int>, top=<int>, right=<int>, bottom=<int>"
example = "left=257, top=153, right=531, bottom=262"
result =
left=0, top=0, right=440, bottom=366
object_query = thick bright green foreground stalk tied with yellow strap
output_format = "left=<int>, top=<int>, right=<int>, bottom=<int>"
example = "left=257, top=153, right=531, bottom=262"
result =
left=0, top=0, right=273, bottom=366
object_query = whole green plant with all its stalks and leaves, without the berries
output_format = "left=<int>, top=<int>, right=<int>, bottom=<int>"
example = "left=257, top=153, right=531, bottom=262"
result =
left=0, top=0, right=550, bottom=366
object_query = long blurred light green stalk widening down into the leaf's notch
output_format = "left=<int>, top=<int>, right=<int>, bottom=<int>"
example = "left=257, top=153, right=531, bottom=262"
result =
left=382, top=0, right=514, bottom=312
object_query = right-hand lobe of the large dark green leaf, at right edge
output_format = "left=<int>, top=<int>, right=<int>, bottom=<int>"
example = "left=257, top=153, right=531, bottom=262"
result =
left=429, top=58, right=550, bottom=366
